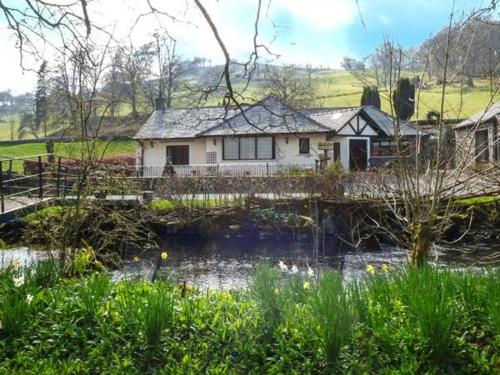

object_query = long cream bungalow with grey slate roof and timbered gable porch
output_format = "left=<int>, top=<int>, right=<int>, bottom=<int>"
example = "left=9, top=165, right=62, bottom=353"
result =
left=134, top=95, right=424, bottom=176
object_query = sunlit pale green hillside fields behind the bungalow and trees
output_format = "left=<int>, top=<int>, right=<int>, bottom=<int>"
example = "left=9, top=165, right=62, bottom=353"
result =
left=0, top=67, right=500, bottom=140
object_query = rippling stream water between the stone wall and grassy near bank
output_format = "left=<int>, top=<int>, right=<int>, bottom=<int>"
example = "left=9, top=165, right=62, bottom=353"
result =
left=0, top=238, right=500, bottom=289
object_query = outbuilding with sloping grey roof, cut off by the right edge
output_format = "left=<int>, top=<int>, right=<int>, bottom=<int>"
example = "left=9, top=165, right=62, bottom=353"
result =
left=455, top=101, right=500, bottom=166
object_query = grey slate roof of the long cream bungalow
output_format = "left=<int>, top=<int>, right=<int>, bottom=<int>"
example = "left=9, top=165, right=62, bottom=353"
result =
left=134, top=95, right=426, bottom=139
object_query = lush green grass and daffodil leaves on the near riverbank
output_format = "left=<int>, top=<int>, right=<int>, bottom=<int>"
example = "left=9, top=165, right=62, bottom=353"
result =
left=0, top=265, right=500, bottom=374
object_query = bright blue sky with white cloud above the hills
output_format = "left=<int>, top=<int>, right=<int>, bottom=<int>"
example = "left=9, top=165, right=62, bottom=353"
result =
left=0, top=0, right=498, bottom=94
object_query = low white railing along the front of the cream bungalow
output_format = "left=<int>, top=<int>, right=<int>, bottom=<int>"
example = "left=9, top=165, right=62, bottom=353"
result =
left=138, top=162, right=315, bottom=177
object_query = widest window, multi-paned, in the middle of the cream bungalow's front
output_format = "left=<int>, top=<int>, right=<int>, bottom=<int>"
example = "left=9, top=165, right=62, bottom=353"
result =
left=223, top=137, right=274, bottom=160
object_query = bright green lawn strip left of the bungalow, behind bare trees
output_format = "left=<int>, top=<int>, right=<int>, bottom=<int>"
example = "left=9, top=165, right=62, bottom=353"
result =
left=0, top=140, right=135, bottom=171
